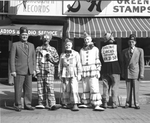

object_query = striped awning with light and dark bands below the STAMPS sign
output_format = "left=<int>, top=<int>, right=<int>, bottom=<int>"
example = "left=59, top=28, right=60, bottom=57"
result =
left=66, top=17, right=150, bottom=38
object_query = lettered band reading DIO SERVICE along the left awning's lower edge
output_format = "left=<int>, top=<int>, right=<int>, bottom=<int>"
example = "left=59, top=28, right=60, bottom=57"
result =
left=0, top=28, right=62, bottom=37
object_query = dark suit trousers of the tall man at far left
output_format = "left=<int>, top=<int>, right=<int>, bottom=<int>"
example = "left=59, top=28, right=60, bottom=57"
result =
left=14, top=75, right=32, bottom=108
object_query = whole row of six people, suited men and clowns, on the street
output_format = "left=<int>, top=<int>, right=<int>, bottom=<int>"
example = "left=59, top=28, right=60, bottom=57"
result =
left=10, top=27, right=144, bottom=111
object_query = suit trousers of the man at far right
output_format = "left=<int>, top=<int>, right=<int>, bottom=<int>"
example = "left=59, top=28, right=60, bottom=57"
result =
left=126, top=79, right=139, bottom=106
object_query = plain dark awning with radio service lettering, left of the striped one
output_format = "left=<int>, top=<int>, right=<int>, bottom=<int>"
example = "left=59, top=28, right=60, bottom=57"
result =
left=0, top=24, right=63, bottom=37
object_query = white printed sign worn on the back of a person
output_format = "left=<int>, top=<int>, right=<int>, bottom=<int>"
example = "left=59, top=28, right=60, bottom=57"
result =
left=101, top=44, right=118, bottom=62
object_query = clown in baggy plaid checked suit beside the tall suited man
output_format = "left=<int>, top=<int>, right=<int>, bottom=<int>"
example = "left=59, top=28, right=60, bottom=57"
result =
left=36, top=34, right=59, bottom=110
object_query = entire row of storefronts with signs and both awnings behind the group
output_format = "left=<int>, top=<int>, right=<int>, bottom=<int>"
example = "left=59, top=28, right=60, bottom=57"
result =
left=0, top=0, right=150, bottom=80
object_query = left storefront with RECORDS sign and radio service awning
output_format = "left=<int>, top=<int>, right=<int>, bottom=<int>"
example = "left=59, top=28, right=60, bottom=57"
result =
left=0, top=1, right=66, bottom=83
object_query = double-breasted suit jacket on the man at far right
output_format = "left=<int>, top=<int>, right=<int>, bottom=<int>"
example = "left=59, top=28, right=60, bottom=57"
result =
left=122, top=47, right=144, bottom=79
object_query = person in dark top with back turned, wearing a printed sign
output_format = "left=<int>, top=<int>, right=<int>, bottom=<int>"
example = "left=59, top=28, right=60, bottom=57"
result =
left=101, top=33, right=122, bottom=108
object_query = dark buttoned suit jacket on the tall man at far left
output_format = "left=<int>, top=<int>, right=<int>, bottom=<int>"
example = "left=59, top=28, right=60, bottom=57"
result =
left=10, top=41, right=35, bottom=75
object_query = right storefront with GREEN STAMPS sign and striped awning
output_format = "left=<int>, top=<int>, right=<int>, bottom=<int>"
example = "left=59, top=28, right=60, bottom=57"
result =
left=64, top=0, right=150, bottom=81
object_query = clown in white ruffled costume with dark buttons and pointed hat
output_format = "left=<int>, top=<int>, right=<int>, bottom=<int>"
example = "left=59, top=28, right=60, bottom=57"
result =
left=80, top=32, right=104, bottom=111
